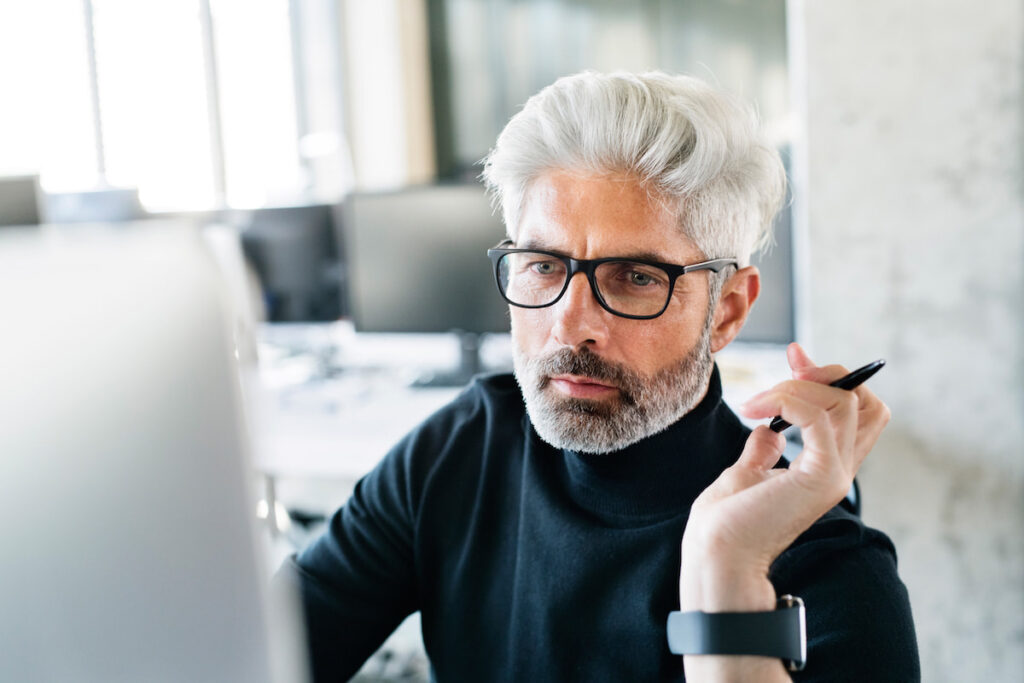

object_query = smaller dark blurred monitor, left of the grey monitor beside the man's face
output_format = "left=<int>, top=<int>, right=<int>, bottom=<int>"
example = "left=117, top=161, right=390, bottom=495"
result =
left=223, top=205, right=345, bottom=323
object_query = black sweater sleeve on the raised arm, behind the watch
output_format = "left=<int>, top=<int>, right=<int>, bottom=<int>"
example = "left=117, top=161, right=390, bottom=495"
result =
left=772, top=509, right=921, bottom=683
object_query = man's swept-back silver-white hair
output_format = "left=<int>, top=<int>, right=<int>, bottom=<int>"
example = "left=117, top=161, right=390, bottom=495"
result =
left=482, top=72, right=785, bottom=266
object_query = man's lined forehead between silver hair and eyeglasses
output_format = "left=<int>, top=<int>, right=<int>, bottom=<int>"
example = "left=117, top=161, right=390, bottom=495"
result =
left=516, top=170, right=701, bottom=263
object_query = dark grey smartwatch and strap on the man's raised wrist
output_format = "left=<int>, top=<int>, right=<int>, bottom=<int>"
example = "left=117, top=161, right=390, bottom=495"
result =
left=668, top=595, right=807, bottom=671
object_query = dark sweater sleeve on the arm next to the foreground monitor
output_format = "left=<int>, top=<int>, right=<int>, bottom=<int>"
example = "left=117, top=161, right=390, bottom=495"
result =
left=275, top=437, right=418, bottom=683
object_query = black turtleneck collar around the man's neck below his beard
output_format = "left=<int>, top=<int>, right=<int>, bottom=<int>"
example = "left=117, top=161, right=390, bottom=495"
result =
left=559, top=365, right=749, bottom=521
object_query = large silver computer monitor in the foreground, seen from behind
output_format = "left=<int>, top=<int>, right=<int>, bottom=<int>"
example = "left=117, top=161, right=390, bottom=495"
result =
left=0, top=226, right=304, bottom=683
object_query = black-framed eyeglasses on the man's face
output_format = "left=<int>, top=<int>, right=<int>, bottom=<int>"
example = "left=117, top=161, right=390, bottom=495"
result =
left=487, top=240, right=738, bottom=319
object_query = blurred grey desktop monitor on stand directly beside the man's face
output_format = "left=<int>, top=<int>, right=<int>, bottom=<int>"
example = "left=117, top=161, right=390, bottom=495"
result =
left=341, top=184, right=509, bottom=384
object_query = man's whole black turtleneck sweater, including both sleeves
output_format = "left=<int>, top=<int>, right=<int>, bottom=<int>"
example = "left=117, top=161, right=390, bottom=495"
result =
left=282, top=369, right=920, bottom=683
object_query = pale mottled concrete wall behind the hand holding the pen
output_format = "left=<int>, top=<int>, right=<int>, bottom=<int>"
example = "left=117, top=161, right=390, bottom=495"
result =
left=790, top=0, right=1024, bottom=682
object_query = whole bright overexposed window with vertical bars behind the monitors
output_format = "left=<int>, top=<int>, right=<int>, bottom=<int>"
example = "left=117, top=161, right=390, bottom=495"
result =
left=0, top=0, right=351, bottom=211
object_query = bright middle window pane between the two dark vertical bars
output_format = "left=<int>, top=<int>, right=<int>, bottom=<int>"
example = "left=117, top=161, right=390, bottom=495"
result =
left=92, top=0, right=215, bottom=210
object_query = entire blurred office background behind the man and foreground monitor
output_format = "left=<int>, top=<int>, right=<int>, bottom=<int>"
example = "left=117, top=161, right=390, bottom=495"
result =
left=0, top=0, right=1024, bottom=681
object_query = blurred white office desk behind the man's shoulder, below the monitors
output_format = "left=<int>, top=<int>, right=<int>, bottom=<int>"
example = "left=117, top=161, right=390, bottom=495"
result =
left=243, top=323, right=493, bottom=542
